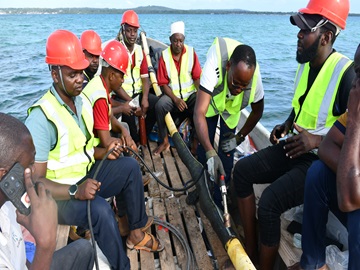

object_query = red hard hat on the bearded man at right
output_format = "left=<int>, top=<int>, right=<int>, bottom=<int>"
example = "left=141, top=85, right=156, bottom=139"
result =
left=299, top=0, right=350, bottom=30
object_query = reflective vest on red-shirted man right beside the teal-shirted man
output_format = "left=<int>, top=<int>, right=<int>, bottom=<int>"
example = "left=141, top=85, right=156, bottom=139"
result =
left=83, top=76, right=112, bottom=146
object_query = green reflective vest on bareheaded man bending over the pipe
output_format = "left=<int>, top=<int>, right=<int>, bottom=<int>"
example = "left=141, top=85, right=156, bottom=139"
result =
left=206, top=37, right=260, bottom=129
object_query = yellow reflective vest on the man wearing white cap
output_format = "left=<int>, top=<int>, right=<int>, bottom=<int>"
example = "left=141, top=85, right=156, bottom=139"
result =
left=162, top=45, right=196, bottom=101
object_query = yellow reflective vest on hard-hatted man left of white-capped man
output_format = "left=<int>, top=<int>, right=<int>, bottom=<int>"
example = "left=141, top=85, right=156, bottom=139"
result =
left=122, top=44, right=144, bottom=97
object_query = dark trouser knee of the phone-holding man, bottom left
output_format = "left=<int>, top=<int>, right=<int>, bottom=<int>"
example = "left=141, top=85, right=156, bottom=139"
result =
left=50, top=239, right=94, bottom=270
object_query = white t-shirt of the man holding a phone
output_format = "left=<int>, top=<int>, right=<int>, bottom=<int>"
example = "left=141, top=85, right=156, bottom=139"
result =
left=0, top=202, right=27, bottom=270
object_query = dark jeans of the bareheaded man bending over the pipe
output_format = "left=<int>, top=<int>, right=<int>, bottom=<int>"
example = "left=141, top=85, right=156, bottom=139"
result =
left=197, top=115, right=235, bottom=208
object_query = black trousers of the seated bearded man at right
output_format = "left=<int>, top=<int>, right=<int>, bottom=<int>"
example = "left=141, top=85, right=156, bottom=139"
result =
left=233, top=141, right=318, bottom=246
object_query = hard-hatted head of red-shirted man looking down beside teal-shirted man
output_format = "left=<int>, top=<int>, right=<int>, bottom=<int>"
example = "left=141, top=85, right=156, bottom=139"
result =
left=101, top=40, right=129, bottom=91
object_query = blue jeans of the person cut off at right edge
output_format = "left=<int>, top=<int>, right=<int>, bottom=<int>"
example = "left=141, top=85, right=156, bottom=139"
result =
left=300, top=160, right=360, bottom=270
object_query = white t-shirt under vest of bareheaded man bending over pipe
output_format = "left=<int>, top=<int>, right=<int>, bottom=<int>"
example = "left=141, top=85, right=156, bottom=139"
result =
left=200, top=44, right=264, bottom=103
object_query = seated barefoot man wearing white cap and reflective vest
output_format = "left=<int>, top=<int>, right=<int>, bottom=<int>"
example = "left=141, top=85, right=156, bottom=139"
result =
left=154, top=21, right=201, bottom=155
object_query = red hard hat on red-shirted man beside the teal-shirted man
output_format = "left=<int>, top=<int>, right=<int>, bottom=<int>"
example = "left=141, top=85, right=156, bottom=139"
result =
left=101, top=40, right=129, bottom=74
